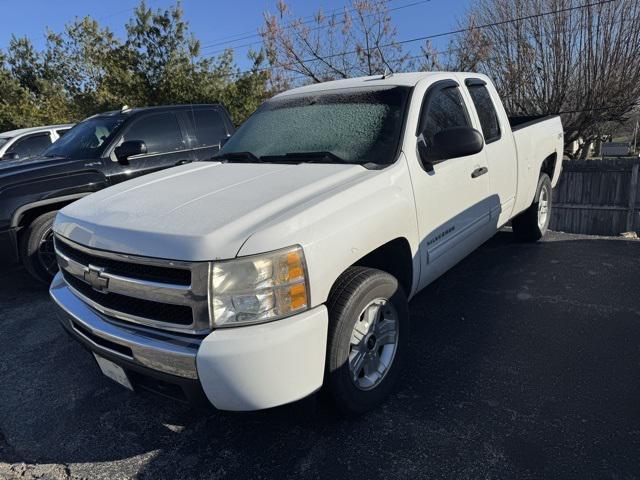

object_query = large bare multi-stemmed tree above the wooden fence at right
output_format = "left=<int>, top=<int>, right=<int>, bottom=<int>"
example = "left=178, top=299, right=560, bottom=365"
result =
left=451, top=0, right=640, bottom=157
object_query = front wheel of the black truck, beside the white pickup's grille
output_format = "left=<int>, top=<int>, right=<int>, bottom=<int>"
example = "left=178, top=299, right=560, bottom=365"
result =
left=20, top=211, right=58, bottom=285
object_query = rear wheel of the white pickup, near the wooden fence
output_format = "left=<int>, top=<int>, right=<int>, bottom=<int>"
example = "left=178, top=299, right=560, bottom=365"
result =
left=511, top=173, right=553, bottom=242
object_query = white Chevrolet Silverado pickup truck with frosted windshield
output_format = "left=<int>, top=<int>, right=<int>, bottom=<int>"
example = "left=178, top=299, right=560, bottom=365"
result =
left=50, top=72, right=563, bottom=413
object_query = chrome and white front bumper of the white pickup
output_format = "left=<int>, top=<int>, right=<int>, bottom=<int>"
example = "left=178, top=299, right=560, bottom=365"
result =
left=50, top=273, right=328, bottom=411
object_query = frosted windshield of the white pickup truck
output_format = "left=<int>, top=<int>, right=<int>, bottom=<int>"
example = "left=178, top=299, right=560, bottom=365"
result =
left=217, top=86, right=409, bottom=165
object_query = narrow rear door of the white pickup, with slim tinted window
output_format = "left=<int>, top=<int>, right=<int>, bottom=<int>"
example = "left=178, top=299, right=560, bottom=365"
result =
left=465, top=77, right=518, bottom=226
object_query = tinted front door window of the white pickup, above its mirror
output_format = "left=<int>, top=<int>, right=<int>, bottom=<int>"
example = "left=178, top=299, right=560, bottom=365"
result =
left=420, top=87, right=470, bottom=147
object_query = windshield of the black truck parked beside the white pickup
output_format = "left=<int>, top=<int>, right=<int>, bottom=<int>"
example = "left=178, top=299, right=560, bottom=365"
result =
left=43, top=115, right=125, bottom=160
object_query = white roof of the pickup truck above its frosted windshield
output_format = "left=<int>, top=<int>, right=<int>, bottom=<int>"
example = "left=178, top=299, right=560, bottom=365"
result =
left=278, top=72, right=485, bottom=97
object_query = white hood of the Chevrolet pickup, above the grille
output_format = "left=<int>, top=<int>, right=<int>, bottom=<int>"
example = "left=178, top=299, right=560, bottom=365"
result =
left=54, top=162, right=373, bottom=261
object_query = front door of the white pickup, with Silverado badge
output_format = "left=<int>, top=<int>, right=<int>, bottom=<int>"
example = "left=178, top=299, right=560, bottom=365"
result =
left=405, top=80, right=497, bottom=288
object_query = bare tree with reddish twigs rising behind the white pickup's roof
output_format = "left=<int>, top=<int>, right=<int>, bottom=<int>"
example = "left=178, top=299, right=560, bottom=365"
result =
left=260, top=0, right=412, bottom=82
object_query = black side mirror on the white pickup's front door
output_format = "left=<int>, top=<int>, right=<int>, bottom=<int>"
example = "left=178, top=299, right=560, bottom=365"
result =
left=418, top=127, right=484, bottom=169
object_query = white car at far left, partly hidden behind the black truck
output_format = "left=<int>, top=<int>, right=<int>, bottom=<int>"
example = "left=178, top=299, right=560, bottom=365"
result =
left=0, top=124, right=73, bottom=160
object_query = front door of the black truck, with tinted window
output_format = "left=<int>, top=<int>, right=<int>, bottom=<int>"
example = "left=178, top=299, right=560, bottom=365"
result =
left=108, top=111, right=193, bottom=183
